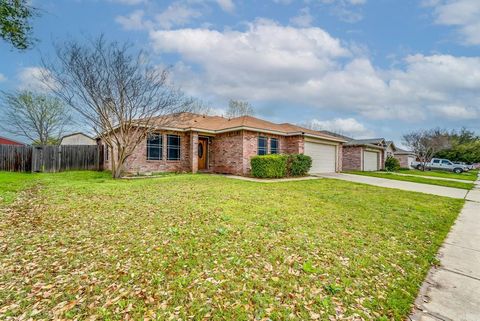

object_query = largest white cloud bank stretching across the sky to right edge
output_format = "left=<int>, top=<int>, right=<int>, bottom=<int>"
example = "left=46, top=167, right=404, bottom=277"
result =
left=150, top=20, right=480, bottom=121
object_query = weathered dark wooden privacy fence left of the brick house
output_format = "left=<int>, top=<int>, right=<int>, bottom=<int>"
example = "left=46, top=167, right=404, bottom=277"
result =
left=0, top=145, right=103, bottom=172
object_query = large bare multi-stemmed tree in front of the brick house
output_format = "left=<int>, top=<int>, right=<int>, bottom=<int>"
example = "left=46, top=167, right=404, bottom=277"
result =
left=43, top=36, right=192, bottom=178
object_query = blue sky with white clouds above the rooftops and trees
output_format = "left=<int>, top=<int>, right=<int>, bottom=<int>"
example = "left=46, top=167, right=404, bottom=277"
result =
left=0, top=0, right=480, bottom=142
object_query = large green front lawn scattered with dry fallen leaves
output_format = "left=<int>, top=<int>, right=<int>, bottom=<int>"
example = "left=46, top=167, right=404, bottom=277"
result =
left=0, top=172, right=463, bottom=320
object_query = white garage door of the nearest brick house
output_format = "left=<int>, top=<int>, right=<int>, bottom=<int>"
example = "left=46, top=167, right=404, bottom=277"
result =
left=304, top=142, right=337, bottom=173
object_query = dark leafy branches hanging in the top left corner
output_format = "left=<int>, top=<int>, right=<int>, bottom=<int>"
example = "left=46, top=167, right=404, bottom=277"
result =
left=0, top=0, right=37, bottom=50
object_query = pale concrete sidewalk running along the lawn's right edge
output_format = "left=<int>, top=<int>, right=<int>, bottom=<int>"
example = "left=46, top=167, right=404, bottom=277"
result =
left=410, top=175, right=480, bottom=321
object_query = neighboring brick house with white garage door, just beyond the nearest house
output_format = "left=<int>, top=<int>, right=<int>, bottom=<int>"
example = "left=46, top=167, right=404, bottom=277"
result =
left=342, top=138, right=386, bottom=171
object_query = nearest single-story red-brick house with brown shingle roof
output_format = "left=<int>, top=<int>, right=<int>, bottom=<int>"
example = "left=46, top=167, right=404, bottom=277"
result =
left=105, top=113, right=345, bottom=175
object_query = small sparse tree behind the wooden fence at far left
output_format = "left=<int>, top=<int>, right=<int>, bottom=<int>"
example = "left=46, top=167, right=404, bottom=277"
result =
left=2, top=91, right=71, bottom=145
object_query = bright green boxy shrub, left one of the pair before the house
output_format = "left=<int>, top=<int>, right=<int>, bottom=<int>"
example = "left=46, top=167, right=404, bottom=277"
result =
left=250, top=154, right=288, bottom=178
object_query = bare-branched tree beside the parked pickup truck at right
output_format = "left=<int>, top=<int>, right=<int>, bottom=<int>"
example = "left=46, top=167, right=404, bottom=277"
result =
left=403, top=128, right=450, bottom=170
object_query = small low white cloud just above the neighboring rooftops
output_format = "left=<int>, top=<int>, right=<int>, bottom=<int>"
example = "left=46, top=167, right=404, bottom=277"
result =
left=309, top=117, right=375, bottom=138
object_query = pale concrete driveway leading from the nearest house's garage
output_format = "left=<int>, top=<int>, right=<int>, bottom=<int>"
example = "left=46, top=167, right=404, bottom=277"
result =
left=319, top=173, right=468, bottom=198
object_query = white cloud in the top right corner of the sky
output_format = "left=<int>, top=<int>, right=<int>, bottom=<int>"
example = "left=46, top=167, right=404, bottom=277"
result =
left=423, top=0, right=480, bottom=45
